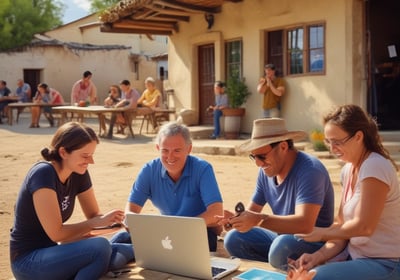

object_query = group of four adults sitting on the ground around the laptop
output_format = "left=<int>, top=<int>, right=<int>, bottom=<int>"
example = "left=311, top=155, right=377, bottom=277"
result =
left=10, top=101, right=400, bottom=280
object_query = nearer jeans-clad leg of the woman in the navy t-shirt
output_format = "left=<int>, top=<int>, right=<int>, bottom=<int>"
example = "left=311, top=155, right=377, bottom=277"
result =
left=11, top=237, right=111, bottom=280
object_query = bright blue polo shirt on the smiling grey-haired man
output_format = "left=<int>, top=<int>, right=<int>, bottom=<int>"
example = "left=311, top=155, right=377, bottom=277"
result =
left=128, top=155, right=222, bottom=217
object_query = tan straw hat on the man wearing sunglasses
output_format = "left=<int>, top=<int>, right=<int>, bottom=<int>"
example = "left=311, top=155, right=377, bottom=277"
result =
left=239, top=118, right=307, bottom=152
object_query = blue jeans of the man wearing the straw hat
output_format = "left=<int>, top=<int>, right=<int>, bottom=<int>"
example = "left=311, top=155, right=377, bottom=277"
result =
left=224, top=230, right=324, bottom=270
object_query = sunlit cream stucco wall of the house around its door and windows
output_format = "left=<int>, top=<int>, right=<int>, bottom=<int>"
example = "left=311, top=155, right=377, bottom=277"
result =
left=169, top=0, right=365, bottom=135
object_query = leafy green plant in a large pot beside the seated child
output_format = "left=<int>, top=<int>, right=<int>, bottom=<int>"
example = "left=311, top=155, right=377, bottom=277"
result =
left=222, top=75, right=251, bottom=139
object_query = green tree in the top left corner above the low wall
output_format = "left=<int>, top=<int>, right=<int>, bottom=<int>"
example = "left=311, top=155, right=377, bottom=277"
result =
left=0, top=0, right=65, bottom=51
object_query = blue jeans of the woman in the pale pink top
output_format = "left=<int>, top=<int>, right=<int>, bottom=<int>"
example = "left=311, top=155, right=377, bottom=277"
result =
left=313, top=258, right=400, bottom=280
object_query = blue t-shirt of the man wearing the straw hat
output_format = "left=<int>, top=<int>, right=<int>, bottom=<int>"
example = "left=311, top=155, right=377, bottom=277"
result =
left=253, top=152, right=334, bottom=227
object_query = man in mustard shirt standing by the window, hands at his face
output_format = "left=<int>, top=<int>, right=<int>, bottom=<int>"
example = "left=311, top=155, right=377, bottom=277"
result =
left=257, top=64, right=285, bottom=118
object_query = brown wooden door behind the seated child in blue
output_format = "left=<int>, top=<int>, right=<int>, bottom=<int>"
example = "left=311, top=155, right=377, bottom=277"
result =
left=198, top=44, right=215, bottom=125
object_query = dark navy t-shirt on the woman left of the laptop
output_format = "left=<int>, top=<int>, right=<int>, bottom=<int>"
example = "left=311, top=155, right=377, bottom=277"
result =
left=10, top=161, right=92, bottom=260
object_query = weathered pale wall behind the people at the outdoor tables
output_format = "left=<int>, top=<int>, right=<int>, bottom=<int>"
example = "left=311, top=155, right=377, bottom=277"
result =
left=0, top=47, right=157, bottom=104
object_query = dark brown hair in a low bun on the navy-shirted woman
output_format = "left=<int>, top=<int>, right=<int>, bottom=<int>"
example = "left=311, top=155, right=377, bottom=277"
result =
left=41, top=122, right=99, bottom=162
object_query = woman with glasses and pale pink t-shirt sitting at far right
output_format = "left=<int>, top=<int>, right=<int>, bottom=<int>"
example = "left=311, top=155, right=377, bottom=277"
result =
left=292, top=105, right=400, bottom=280
